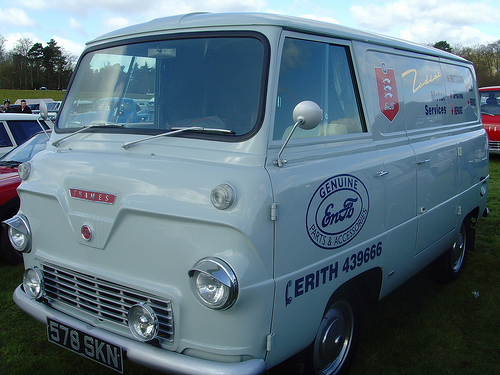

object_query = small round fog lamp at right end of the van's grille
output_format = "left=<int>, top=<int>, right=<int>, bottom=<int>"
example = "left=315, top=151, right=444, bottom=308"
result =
left=128, top=302, right=159, bottom=341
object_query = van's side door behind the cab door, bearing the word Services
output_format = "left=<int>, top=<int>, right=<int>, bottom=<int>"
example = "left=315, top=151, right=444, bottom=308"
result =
left=398, top=57, right=458, bottom=254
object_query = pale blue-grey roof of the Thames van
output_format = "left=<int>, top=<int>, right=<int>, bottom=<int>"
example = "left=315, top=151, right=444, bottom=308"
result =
left=88, top=12, right=466, bottom=62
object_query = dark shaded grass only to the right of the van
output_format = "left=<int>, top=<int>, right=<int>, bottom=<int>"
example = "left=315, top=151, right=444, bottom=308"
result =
left=350, top=156, right=500, bottom=375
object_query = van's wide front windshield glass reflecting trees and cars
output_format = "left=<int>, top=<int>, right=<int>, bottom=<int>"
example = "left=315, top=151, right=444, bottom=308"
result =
left=57, top=33, right=268, bottom=138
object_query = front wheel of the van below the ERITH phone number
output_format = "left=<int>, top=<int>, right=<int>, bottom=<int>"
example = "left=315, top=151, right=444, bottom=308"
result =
left=312, top=295, right=360, bottom=375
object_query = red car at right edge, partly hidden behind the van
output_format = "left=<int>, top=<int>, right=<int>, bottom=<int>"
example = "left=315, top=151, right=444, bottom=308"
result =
left=479, top=86, right=500, bottom=154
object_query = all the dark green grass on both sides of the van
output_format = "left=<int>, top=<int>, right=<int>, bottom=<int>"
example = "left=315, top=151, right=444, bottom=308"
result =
left=0, top=157, right=500, bottom=375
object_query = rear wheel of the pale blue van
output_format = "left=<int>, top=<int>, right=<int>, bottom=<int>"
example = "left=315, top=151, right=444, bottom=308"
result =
left=435, top=220, right=474, bottom=283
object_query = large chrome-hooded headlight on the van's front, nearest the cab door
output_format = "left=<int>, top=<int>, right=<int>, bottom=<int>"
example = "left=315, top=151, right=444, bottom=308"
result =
left=188, top=257, right=239, bottom=310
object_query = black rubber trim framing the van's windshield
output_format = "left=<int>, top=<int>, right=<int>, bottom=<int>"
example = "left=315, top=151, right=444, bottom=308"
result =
left=54, top=30, right=271, bottom=142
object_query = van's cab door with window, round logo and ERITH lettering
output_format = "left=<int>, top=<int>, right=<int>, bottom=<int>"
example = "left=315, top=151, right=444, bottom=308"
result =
left=266, top=33, right=385, bottom=362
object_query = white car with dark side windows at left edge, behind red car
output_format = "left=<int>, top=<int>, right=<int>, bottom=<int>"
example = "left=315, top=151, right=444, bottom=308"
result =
left=0, top=113, right=52, bottom=156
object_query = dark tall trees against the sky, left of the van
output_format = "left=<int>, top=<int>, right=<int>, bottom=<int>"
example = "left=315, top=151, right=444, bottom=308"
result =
left=0, top=35, right=77, bottom=90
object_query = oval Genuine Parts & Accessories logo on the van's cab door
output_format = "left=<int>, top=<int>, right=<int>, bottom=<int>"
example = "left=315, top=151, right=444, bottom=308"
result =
left=306, top=174, right=369, bottom=249
